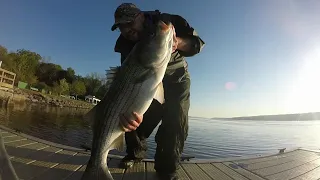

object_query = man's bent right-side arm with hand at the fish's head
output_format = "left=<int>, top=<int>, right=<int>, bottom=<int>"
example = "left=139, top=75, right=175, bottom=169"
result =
left=172, top=15, right=205, bottom=57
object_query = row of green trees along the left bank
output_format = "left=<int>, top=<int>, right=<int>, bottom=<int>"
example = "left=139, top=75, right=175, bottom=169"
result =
left=0, top=45, right=106, bottom=98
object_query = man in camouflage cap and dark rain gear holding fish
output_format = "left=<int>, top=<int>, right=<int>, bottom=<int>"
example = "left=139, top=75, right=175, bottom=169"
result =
left=111, top=3, right=204, bottom=179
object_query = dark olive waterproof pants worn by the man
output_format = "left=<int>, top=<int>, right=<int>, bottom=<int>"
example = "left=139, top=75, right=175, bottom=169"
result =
left=125, top=68, right=190, bottom=173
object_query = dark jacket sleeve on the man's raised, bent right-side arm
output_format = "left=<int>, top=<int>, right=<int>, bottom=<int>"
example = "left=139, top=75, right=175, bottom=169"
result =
left=171, top=15, right=205, bottom=57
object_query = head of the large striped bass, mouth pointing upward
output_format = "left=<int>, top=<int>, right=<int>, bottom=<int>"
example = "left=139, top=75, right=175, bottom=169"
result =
left=136, top=20, right=174, bottom=68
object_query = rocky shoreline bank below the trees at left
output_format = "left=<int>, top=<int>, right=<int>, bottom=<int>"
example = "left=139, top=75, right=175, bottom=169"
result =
left=0, top=88, right=94, bottom=109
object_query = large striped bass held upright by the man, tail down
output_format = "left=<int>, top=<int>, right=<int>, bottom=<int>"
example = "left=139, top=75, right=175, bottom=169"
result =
left=82, top=21, right=173, bottom=180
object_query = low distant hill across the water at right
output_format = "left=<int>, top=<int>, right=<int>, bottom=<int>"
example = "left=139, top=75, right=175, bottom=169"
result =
left=229, top=112, right=320, bottom=121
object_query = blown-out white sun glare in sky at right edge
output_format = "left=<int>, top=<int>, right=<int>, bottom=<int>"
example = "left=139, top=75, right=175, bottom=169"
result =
left=287, top=46, right=320, bottom=112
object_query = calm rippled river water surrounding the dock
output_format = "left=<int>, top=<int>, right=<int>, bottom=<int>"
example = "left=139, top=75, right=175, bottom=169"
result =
left=0, top=104, right=320, bottom=159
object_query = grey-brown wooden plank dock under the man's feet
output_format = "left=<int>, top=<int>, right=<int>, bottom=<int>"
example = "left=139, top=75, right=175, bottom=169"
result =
left=0, top=126, right=320, bottom=180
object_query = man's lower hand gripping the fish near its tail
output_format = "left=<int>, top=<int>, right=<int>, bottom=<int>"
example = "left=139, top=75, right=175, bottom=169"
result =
left=119, top=112, right=143, bottom=132
